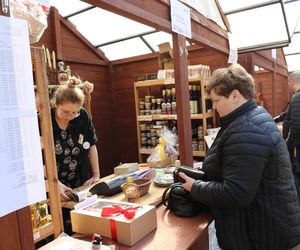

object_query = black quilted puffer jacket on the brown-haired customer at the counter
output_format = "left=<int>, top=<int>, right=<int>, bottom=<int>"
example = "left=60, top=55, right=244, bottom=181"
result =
left=191, top=100, right=300, bottom=250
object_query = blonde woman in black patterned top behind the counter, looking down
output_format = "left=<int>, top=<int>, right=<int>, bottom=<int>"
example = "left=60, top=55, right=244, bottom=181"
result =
left=51, top=78, right=100, bottom=201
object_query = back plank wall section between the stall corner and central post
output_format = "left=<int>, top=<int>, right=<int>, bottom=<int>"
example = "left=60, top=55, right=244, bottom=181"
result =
left=113, top=55, right=158, bottom=162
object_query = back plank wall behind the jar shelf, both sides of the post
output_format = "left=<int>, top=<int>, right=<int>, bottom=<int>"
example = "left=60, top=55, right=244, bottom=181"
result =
left=113, top=49, right=227, bottom=162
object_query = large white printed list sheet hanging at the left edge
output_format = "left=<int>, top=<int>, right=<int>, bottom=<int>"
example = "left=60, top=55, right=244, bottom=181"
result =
left=0, top=16, right=46, bottom=216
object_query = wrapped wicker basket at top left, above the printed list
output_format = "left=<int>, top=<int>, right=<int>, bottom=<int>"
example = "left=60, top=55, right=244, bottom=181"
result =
left=9, top=0, right=47, bottom=43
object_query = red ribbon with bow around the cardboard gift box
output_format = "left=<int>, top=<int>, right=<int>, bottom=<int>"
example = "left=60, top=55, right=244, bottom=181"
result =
left=101, top=205, right=139, bottom=241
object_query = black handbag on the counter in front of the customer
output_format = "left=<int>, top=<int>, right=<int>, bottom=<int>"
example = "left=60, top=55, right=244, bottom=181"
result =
left=162, top=183, right=204, bottom=217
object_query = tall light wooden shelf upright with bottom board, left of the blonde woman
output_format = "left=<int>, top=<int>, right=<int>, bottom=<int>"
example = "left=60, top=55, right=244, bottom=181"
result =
left=31, top=48, right=63, bottom=243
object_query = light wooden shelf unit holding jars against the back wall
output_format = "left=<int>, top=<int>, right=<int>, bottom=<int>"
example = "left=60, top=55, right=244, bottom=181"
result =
left=134, top=76, right=215, bottom=162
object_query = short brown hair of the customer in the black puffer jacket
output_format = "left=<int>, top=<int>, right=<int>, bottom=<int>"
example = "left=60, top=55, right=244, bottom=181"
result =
left=206, top=64, right=255, bottom=100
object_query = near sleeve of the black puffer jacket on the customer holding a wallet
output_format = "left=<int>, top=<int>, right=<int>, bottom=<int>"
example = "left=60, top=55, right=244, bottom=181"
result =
left=191, top=127, right=273, bottom=208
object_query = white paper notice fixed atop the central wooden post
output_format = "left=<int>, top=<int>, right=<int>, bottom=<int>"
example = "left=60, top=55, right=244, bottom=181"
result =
left=171, top=0, right=192, bottom=38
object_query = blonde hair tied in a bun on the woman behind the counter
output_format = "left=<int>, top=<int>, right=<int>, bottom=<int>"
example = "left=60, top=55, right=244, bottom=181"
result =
left=54, top=77, right=84, bottom=106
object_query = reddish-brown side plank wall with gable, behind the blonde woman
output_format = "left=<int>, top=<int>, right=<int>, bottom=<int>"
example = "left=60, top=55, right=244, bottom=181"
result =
left=34, top=9, right=117, bottom=176
